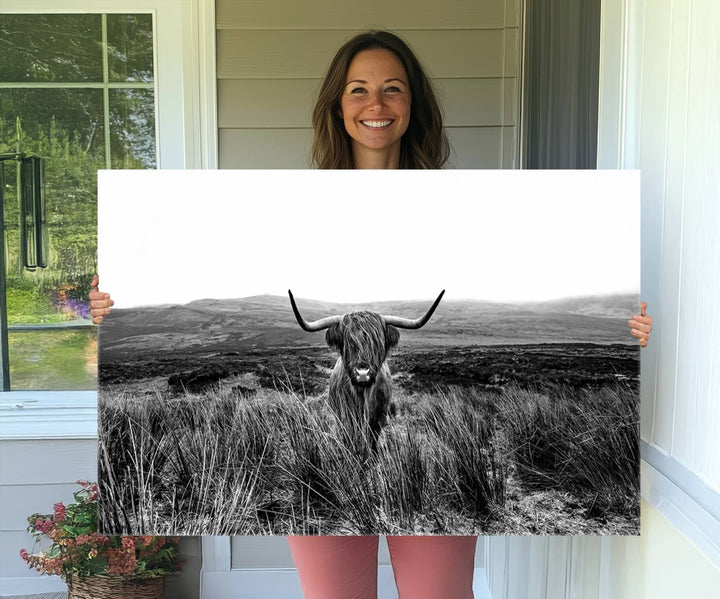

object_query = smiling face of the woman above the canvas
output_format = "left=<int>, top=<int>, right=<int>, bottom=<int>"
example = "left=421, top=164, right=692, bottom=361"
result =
left=340, top=49, right=411, bottom=159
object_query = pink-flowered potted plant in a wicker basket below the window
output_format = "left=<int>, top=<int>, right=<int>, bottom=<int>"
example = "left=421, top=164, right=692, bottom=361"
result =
left=20, top=481, right=182, bottom=599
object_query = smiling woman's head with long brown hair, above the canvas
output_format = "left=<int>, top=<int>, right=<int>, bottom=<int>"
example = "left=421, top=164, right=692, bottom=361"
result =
left=312, top=31, right=450, bottom=169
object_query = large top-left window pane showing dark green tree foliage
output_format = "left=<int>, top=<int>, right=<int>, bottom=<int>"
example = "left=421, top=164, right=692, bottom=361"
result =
left=0, top=15, right=102, bottom=82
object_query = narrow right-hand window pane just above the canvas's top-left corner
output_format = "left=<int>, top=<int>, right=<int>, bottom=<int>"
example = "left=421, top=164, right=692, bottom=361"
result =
left=110, top=89, right=156, bottom=169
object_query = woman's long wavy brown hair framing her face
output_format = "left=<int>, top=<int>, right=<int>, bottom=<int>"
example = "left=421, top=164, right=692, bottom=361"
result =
left=312, top=31, right=450, bottom=169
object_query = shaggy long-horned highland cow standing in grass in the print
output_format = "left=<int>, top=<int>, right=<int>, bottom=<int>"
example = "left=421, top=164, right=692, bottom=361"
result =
left=288, top=290, right=445, bottom=452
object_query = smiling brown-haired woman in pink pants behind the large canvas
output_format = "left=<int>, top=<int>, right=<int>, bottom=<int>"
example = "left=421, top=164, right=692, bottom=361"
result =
left=288, top=31, right=476, bottom=599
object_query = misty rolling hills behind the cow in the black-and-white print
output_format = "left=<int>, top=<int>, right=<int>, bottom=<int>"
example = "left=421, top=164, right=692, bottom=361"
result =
left=100, top=295, right=639, bottom=359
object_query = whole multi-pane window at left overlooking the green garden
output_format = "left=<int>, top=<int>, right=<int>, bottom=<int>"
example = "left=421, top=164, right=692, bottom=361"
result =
left=0, top=14, right=157, bottom=389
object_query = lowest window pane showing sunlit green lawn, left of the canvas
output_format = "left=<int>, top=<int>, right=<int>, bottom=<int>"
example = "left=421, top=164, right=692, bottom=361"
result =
left=8, top=329, right=97, bottom=390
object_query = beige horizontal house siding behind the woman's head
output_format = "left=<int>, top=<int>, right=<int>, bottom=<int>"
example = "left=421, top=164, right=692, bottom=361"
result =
left=216, top=0, right=521, bottom=168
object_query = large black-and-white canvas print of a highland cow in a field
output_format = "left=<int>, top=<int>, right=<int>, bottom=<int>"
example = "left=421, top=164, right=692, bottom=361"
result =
left=98, top=170, right=640, bottom=535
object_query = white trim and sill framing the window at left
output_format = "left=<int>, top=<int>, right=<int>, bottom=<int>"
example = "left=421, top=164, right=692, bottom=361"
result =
left=0, top=0, right=218, bottom=439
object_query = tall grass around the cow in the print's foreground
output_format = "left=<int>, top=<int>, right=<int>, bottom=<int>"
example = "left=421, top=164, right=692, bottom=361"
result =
left=99, top=381, right=639, bottom=535
